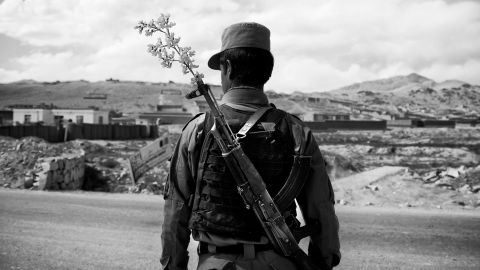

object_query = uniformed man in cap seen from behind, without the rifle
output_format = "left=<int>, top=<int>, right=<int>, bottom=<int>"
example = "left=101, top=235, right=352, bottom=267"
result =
left=161, top=23, right=340, bottom=270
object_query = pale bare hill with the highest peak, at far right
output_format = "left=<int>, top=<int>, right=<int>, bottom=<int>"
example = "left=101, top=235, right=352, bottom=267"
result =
left=318, top=73, right=480, bottom=117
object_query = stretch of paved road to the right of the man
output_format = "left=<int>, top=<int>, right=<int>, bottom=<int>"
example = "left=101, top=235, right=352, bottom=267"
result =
left=338, top=207, right=480, bottom=270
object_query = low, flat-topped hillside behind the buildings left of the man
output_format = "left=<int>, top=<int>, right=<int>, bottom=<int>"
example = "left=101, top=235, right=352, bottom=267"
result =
left=0, top=80, right=220, bottom=113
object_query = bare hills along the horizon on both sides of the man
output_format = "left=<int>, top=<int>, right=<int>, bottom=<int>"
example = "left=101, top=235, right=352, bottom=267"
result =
left=0, top=73, right=480, bottom=119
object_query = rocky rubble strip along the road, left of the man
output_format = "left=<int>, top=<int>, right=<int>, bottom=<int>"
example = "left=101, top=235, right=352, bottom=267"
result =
left=0, top=137, right=168, bottom=194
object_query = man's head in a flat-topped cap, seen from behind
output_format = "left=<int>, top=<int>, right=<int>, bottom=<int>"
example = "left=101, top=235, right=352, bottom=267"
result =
left=208, top=23, right=274, bottom=91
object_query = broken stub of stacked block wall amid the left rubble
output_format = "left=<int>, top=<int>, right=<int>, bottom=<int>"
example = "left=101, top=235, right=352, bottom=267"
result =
left=35, top=150, right=85, bottom=190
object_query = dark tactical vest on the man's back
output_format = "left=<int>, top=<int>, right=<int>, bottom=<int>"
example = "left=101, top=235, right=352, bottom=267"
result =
left=189, top=105, right=298, bottom=240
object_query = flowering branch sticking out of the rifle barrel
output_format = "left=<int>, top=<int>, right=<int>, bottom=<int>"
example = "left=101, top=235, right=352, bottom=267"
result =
left=135, top=14, right=204, bottom=84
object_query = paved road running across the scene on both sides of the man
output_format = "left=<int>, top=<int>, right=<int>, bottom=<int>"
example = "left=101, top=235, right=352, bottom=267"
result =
left=0, top=189, right=480, bottom=270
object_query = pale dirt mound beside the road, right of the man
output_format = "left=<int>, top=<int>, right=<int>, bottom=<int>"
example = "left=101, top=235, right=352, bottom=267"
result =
left=332, top=166, right=480, bottom=209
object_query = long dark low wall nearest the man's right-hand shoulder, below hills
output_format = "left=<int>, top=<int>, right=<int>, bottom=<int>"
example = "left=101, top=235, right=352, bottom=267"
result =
left=305, top=120, right=387, bottom=131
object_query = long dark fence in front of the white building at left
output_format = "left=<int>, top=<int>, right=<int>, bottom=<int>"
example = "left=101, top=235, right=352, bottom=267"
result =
left=0, top=124, right=158, bottom=142
